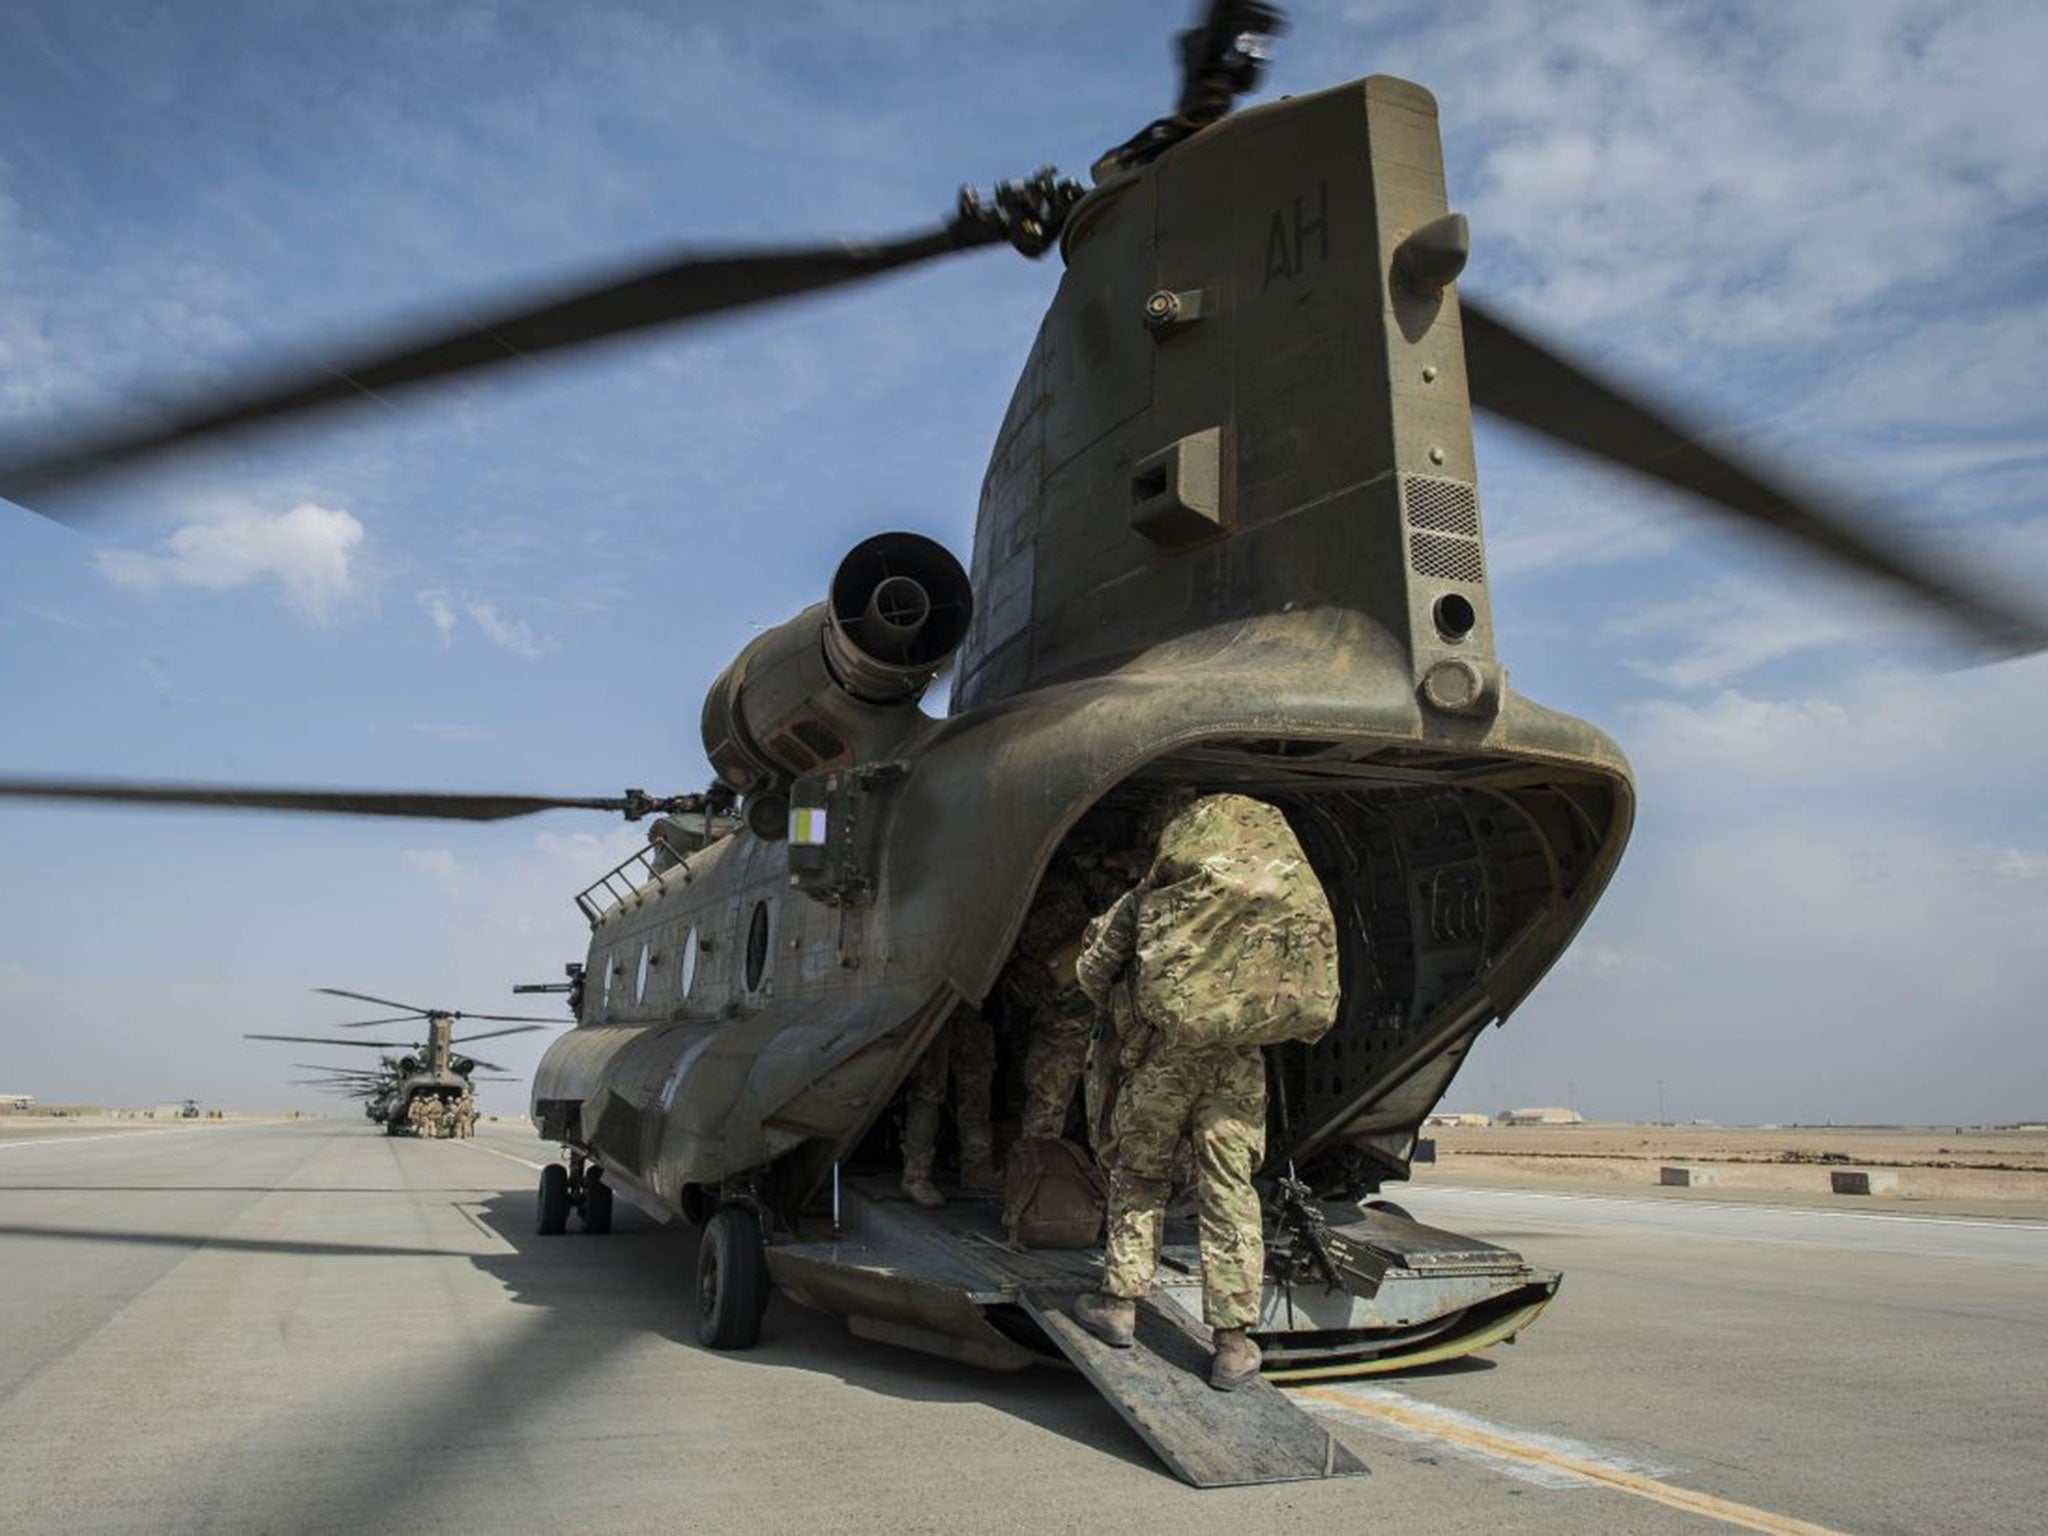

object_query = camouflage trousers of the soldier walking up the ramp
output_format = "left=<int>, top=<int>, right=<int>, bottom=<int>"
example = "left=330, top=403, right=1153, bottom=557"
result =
left=1102, top=1038, right=1266, bottom=1327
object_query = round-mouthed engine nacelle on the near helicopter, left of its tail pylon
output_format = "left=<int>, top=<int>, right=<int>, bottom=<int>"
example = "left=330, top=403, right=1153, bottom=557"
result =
left=705, top=532, right=975, bottom=797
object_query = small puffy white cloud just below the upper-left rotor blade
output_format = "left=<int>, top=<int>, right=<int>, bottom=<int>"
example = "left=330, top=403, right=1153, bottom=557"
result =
left=94, top=502, right=362, bottom=623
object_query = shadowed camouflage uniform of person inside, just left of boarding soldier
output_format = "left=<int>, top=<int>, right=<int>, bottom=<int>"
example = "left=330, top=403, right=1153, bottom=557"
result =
left=1004, top=848, right=1116, bottom=1137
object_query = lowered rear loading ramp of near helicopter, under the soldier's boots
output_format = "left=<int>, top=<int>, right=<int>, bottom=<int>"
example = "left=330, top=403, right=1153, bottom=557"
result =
left=766, top=1176, right=1559, bottom=1487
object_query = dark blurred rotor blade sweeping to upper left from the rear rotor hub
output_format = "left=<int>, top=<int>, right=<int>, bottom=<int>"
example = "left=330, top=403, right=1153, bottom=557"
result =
left=0, top=219, right=1001, bottom=522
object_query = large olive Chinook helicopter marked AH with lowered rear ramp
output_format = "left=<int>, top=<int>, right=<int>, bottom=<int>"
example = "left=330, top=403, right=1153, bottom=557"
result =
left=0, top=0, right=2048, bottom=1483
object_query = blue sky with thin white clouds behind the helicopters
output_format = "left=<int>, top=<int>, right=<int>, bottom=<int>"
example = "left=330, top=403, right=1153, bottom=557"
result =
left=0, top=0, right=2048, bottom=1120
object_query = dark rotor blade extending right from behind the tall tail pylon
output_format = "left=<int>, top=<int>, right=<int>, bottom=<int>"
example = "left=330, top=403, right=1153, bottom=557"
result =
left=1458, top=295, right=2048, bottom=655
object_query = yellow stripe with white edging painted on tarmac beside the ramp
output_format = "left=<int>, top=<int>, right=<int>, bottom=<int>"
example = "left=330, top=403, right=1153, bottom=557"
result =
left=1288, top=1384, right=1839, bottom=1536
